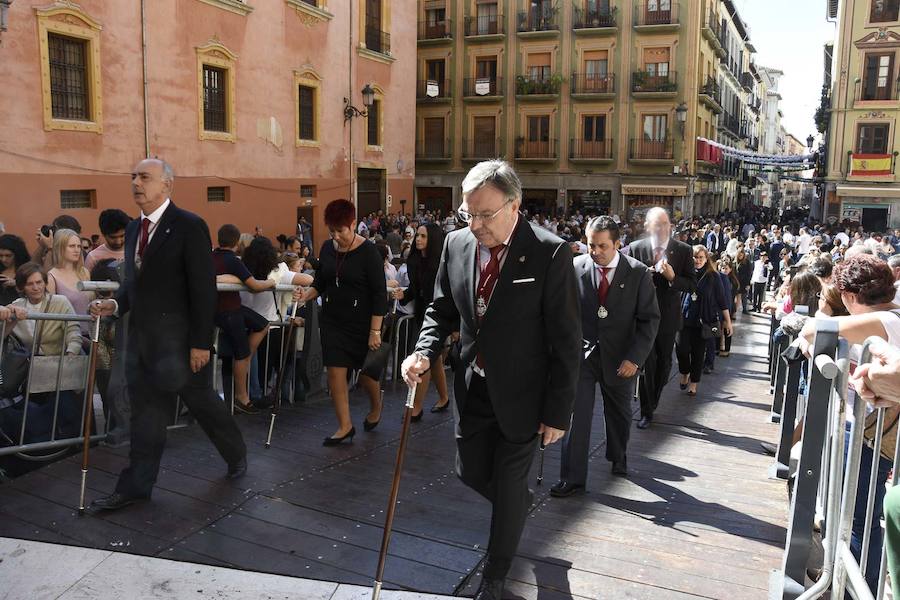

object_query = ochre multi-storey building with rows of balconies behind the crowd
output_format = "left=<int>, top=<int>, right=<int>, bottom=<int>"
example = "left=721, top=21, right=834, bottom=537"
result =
left=416, top=0, right=772, bottom=219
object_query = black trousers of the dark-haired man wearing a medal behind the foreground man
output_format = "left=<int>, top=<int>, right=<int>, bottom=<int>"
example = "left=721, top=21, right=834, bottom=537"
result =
left=559, top=350, right=634, bottom=485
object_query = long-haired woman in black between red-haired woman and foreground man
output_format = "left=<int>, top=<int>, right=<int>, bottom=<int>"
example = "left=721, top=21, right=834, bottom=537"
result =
left=394, top=223, right=450, bottom=422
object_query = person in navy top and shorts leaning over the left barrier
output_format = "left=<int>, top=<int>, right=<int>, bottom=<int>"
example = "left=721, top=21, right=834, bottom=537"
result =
left=213, top=225, right=275, bottom=414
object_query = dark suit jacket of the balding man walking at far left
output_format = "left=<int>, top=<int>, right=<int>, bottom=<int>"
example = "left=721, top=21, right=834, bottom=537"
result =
left=116, top=199, right=217, bottom=391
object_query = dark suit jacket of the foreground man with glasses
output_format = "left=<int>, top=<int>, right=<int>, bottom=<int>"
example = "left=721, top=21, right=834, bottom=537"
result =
left=416, top=215, right=581, bottom=441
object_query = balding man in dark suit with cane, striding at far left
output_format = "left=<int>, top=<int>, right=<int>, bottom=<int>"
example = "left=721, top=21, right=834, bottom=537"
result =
left=91, top=159, right=247, bottom=510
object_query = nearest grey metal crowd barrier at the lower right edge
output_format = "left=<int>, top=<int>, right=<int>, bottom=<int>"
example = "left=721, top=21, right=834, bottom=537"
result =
left=769, top=318, right=900, bottom=600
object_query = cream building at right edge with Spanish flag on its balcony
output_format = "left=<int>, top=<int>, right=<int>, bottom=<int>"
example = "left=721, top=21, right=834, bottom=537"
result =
left=825, top=0, right=900, bottom=231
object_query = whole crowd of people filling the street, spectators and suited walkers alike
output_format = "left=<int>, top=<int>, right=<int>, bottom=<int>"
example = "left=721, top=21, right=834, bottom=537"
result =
left=0, top=159, right=900, bottom=600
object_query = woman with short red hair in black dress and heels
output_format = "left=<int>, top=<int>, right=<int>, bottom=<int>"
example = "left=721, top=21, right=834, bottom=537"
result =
left=301, top=199, right=388, bottom=446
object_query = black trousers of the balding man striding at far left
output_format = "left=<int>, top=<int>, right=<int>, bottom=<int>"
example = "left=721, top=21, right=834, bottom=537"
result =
left=116, top=357, right=247, bottom=498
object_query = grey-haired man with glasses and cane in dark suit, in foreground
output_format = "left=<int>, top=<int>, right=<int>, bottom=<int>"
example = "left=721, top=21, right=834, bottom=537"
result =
left=402, top=160, right=581, bottom=600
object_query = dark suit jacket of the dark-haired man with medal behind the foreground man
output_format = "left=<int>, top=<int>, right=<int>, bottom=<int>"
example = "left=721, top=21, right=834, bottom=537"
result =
left=575, top=253, right=659, bottom=384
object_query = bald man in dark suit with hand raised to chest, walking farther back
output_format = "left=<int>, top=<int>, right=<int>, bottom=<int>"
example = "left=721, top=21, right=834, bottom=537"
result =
left=626, top=207, right=697, bottom=429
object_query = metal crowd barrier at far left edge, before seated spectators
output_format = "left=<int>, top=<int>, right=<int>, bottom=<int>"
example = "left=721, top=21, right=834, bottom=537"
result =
left=0, top=312, right=105, bottom=461
